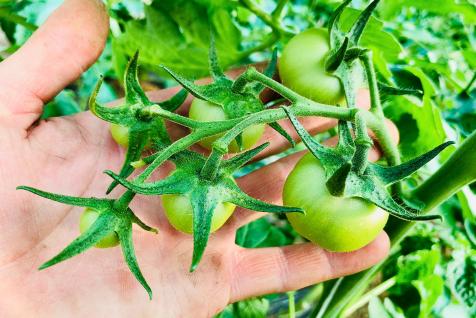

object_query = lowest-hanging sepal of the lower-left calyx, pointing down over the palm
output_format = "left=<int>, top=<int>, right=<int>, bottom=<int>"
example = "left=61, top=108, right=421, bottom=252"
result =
left=116, top=217, right=152, bottom=300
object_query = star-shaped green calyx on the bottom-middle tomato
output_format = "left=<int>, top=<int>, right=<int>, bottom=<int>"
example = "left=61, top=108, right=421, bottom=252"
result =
left=105, top=143, right=304, bottom=271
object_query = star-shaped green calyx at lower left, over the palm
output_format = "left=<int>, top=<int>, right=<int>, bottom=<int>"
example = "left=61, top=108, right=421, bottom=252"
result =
left=17, top=186, right=158, bottom=299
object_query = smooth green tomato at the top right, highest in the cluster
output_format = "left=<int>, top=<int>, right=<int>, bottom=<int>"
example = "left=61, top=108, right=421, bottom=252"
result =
left=278, top=29, right=344, bottom=105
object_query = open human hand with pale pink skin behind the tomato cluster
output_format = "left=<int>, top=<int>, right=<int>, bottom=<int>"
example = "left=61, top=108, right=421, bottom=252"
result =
left=0, top=0, right=396, bottom=317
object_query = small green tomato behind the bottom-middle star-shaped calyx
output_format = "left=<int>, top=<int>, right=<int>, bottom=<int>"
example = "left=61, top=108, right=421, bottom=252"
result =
left=162, top=194, right=236, bottom=234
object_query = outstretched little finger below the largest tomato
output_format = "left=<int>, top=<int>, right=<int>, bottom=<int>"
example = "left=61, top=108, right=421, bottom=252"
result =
left=230, top=232, right=390, bottom=302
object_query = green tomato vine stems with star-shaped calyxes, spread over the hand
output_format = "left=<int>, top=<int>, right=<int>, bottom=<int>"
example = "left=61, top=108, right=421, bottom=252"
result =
left=13, top=0, right=475, bottom=308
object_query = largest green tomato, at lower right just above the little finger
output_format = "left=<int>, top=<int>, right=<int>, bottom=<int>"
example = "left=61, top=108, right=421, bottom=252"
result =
left=283, top=153, right=388, bottom=252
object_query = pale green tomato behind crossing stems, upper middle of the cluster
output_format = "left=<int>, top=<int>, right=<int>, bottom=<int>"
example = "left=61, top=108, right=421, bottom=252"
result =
left=188, top=98, right=265, bottom=152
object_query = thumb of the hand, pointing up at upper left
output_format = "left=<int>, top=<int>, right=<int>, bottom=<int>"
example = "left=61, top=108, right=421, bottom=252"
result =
left=0, top=0, right=108, bottom=128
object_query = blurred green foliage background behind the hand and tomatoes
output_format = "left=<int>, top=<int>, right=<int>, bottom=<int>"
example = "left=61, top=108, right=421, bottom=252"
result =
left=0, top=0, right=476, bottom=318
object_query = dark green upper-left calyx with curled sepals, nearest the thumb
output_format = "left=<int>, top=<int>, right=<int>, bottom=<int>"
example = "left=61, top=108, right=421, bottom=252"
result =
left=89, top=52, right=187, bottom=194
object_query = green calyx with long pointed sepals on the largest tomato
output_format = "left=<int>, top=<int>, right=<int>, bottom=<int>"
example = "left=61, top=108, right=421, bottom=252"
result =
left=283, top=107, right=453, bottom=221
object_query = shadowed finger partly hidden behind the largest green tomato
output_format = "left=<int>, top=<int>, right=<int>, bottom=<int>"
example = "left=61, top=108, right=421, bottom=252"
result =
left=225, top=137, right=386, bottom=231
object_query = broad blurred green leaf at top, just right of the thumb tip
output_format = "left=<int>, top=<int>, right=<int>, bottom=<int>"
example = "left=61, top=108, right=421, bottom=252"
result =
left=113, top=0, right=241, bottom=77
